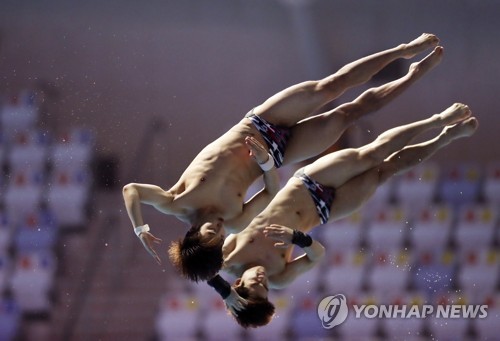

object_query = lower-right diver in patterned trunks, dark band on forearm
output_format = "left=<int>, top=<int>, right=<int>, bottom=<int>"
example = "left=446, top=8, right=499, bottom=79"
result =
left=208, top=103, right=478, bottom=327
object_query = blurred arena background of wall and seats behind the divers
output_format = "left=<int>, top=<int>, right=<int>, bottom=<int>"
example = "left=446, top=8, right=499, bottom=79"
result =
left=0, top=0, right=500, bottom=340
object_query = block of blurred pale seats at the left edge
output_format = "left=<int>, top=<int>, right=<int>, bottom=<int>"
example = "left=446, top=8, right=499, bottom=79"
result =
left=0, top=90, right=95, bottom=341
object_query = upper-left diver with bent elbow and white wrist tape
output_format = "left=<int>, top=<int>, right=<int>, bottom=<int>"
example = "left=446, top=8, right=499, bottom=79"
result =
left=123, top=34, right=442, bottom=281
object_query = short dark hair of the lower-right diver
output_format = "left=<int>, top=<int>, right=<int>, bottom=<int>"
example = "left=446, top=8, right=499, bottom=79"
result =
left=233, top=286, right=274, bottom=328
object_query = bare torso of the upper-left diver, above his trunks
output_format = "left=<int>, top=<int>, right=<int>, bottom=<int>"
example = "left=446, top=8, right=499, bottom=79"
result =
left=168, top=119, right=264, bottom=223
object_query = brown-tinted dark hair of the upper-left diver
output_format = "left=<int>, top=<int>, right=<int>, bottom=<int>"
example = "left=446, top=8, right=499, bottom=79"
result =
left=168, top=225, right=223, bottom=282
